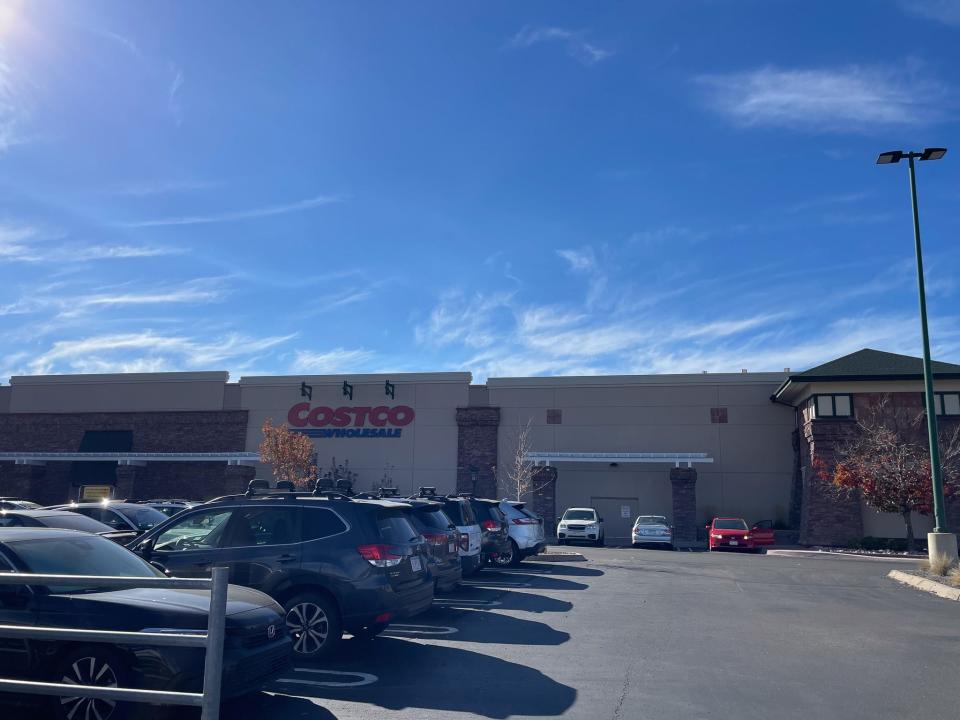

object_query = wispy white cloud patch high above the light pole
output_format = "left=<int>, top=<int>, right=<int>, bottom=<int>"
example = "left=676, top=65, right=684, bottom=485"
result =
left=697, top=66, right=952, bottom=132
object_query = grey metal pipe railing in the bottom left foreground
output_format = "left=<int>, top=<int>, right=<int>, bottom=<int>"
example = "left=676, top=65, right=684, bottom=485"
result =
left=0, top=567, right=228, bottom=720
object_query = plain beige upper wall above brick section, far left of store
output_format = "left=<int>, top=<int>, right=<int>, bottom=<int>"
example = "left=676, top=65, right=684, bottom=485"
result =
left=7, top=372, right=229, bottom=413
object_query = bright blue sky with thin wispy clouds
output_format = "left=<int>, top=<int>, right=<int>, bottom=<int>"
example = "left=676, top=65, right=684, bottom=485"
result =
left=0, top=0, right=960, bottom=381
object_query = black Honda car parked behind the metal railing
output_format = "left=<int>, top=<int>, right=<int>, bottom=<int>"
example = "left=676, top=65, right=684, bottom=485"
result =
left=0, top=528, right=292, bottom=720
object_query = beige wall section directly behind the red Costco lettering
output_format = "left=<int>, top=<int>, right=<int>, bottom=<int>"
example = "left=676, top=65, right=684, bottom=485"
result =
left=239, top=373, right=470, bottom=492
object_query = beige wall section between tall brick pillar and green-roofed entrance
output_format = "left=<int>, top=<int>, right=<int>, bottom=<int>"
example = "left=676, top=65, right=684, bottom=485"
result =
left=488, top=373, right=795, bottom=523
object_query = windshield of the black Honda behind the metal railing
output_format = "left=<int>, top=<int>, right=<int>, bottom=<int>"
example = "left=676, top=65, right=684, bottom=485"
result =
left=7, top=533, right=163, bottom=594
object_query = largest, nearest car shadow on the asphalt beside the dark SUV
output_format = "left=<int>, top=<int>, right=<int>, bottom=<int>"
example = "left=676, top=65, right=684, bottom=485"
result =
left=266, top=637, right=577, bottom=718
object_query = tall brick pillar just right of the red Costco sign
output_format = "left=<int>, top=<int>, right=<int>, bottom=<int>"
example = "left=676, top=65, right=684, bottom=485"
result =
left=458, top=407, right=500, bottom=498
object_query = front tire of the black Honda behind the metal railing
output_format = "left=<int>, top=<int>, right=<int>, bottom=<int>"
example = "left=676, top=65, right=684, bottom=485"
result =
left=50, top=645, right=131, bottom=720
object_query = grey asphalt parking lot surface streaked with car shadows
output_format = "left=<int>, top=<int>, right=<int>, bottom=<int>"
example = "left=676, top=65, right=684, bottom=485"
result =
left=204, top=548, right=960, bottom=720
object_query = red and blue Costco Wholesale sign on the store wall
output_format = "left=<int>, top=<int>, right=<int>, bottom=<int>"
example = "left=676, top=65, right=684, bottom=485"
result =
left=287, top=402, right=416, bottom=438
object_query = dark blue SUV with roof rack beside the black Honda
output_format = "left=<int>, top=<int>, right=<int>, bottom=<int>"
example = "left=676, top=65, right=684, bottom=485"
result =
left=133, top=488, right=433, bottom=659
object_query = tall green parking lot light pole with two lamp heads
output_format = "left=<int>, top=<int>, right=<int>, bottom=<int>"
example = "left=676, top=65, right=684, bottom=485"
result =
left=877, top=148, right=957, bottom=560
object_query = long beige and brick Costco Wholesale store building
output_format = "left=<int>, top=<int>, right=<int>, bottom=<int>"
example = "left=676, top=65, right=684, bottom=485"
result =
left=0, top=350, right=960, bottom=544
